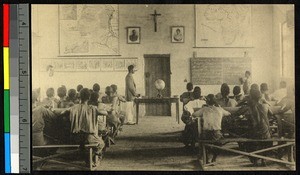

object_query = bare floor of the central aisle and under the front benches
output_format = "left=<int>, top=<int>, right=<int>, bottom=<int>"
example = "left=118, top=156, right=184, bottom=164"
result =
left=37, top=116, right=291, bottom=171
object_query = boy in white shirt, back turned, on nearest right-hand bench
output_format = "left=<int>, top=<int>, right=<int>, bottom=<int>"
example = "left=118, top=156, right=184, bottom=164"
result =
left=193, top=94, right=230, bottom=162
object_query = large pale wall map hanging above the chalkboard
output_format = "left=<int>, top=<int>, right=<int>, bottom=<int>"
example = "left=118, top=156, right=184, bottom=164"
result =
left=195, top=5, right=252, bottom=47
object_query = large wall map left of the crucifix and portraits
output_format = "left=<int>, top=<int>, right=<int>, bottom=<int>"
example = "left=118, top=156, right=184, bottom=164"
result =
left=59, top=4, right=119, bottom=56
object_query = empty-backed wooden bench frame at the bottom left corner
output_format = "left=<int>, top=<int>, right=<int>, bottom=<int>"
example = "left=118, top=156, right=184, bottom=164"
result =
left=32, top=144, right=100, bottom=171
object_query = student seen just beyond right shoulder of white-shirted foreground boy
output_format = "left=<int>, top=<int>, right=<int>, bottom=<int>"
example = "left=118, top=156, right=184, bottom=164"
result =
left=217, top=83, right=238, bottom=107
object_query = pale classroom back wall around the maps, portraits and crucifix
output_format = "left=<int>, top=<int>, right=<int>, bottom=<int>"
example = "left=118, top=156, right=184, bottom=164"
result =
left=32, top=5, right=288, bottom=100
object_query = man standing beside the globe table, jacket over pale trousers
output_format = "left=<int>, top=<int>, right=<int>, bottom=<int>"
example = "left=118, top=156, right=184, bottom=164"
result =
left=125, top=65, right=139, bottom=125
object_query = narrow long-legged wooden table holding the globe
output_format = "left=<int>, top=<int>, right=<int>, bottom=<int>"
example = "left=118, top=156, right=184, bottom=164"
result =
left=134, top=97, right=180, bottom=124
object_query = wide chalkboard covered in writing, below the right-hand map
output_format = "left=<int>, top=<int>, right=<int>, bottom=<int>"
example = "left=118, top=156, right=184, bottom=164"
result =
left=190, top=57, right=251, bottom=85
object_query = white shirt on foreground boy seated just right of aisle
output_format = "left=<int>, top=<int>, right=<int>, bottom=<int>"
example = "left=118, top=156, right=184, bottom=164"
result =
left=193, top=106, right=230, bottom=131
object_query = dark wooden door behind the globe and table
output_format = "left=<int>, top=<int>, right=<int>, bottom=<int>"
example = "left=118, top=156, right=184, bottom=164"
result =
left=144, top=54, right=171, bottom=116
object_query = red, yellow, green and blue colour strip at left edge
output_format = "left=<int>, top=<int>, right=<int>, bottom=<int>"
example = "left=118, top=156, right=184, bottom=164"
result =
left=3, top=4, right=11, bottom=173
